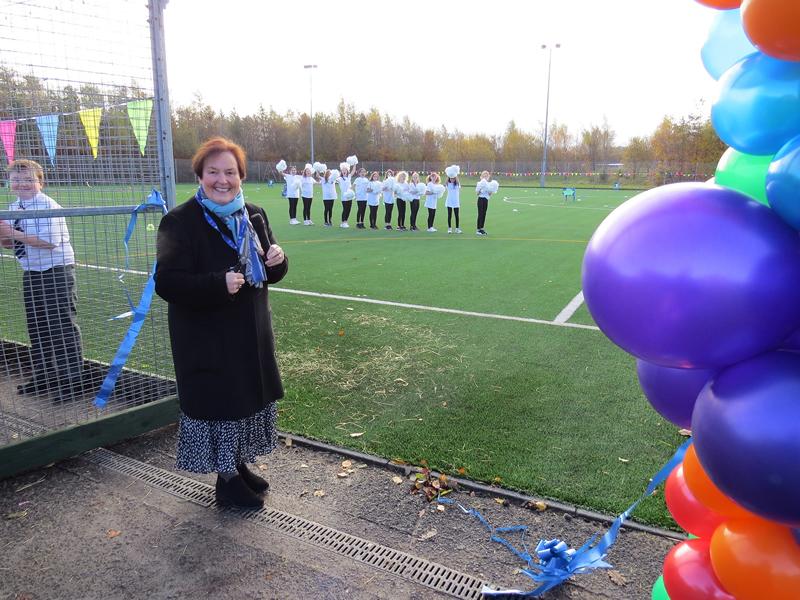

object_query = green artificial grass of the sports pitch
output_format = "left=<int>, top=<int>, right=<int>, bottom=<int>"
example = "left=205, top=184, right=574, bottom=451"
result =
left=0, top=180, right=680, bottom=526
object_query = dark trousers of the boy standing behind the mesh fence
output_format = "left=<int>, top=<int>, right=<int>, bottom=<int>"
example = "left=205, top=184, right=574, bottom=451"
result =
left=22, top=265, right=83, bottom=385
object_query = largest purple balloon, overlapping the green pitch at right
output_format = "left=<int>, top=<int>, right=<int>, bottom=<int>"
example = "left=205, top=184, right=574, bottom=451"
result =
left=583, top=183, right=800, bottom=369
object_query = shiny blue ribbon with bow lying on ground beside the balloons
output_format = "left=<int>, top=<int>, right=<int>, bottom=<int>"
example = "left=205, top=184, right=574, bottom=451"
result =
left=438, top=439, right=692, bottom=598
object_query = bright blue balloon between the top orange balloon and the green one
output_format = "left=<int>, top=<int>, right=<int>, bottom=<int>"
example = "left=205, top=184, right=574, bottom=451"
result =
left=711, top=52, right=800, bottom=156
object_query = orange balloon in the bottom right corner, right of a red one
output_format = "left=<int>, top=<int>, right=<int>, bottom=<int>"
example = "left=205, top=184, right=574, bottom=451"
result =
left=711, top=519, right=800, bottom=600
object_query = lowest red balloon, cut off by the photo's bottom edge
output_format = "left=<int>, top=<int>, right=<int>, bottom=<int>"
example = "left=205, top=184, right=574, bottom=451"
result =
left=664, top=538, right=735, bottom=600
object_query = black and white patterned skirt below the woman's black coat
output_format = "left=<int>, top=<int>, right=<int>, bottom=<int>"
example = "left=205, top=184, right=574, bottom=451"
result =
left=175, top=402, right=278, bottom=473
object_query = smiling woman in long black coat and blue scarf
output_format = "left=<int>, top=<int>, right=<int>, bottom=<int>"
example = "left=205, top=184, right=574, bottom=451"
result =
left=155, top=138, right=288, bottom=508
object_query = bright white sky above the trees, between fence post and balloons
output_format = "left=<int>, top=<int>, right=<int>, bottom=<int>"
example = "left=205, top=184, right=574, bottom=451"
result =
left=165, top=0, right=716, bottom=143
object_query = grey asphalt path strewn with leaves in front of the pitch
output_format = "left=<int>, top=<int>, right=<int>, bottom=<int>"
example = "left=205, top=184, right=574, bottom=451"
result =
left=0, top=427, right=675, bottom=600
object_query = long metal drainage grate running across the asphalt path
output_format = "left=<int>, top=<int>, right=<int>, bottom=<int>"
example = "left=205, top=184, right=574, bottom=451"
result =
left=84, top=448, right=494, bottom=600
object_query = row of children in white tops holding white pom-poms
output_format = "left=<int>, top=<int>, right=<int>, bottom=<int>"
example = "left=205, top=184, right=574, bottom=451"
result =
left=276, top=161, right=499, bottom=235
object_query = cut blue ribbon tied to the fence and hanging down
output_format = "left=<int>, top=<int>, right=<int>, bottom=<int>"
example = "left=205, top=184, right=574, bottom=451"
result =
left=94, top=189, right=167, bottom=408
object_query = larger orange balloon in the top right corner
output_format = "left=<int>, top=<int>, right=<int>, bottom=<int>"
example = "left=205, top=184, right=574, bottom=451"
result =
left=742, top=0, right=800, bottom=61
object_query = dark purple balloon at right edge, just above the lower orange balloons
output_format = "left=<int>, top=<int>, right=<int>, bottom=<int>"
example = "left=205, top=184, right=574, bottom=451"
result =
left=692, top=352, right=800, bottom=527
